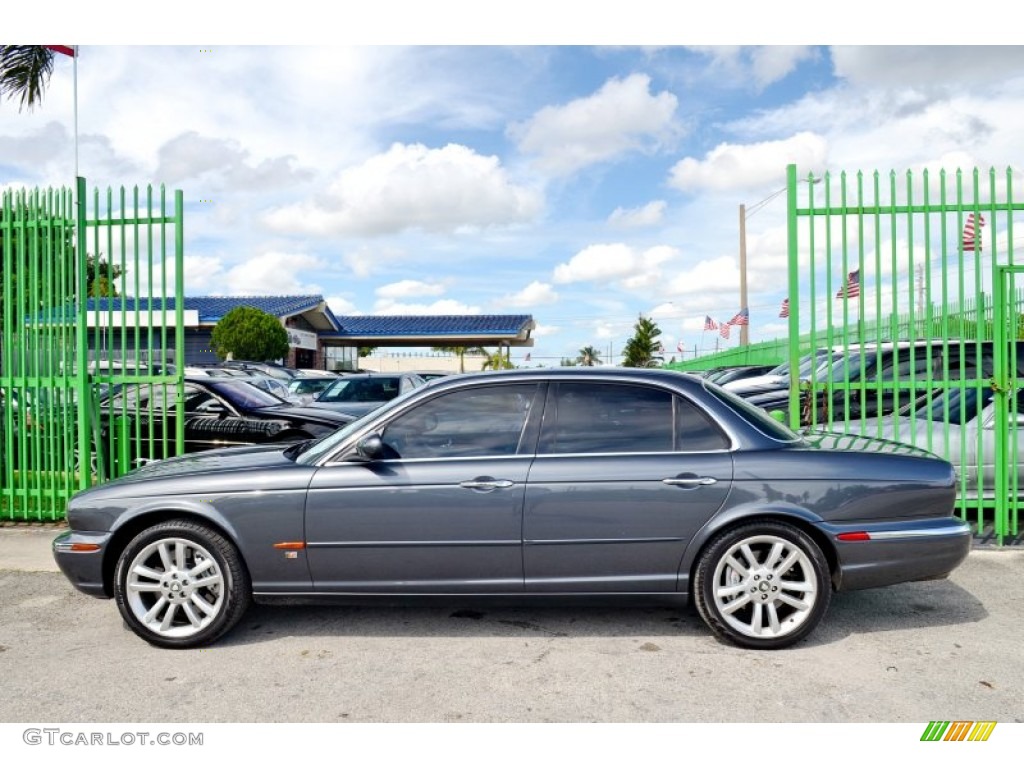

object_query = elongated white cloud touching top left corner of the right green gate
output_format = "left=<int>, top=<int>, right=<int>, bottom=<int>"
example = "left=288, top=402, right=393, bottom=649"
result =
left=669, top=131, right=828, bottom=193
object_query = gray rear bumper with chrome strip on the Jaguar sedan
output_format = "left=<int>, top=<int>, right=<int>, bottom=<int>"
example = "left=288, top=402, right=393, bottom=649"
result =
left=819, top=517, right=972, bottom=590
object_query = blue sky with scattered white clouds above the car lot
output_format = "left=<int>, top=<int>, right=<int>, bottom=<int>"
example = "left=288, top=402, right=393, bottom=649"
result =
left=0, top=5, right=1024, bottom=365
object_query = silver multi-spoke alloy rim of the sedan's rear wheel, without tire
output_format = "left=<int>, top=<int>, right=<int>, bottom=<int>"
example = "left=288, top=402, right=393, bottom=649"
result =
left=712, top=535, right=820, bottom=639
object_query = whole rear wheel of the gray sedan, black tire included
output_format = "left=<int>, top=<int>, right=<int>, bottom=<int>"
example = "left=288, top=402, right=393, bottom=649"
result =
left=693, top=521, right=831, bottom=650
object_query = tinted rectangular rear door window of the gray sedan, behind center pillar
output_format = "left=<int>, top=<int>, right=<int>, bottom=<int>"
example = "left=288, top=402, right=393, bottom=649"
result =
left=540, top=383, right=675, bottom=454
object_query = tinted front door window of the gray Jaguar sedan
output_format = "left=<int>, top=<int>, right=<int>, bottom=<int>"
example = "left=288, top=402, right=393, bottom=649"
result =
left=381, top=383, right=539, bottom=459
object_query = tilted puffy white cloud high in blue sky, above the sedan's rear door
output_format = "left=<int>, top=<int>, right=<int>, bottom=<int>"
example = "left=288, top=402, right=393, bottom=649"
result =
left=509, top=75, right=678, bottom=175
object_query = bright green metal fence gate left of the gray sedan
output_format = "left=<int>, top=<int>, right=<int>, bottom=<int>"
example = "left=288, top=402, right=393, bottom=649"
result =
left=0, top=178, right=184, bottom=520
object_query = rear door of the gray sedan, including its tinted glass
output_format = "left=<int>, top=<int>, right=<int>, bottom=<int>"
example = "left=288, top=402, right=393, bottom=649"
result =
left=523, top=381, right=732, bottom=592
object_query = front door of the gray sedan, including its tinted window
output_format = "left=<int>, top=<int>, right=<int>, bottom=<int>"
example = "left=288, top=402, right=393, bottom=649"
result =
left=306, top=383, right=542, bottom=594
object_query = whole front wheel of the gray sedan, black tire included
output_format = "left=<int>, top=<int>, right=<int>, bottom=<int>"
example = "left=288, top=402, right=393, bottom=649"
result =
left=114, top=520, right=252, bottom=648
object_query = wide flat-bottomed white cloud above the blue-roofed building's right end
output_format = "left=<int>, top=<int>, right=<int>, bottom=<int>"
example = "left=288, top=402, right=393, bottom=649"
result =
left=265, top=143, right=543, bottom=236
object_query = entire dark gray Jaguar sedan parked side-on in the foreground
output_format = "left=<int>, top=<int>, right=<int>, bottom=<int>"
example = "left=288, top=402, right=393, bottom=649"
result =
left=53, top=368, right=972, bottom=648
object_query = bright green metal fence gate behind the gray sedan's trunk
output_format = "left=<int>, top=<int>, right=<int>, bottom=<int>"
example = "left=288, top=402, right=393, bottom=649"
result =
left=786, top=166, right=1024, bottom=543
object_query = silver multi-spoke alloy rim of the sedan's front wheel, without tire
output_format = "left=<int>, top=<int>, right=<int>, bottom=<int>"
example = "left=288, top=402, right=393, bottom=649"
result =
left=125, top=538, right=225, bottom=638
